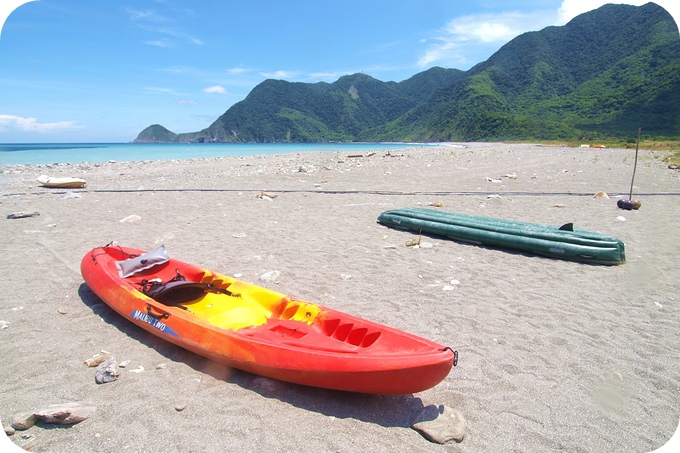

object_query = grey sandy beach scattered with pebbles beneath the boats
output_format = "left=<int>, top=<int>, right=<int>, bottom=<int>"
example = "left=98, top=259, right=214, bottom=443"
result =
left=0, top=143, right=680, bottom=452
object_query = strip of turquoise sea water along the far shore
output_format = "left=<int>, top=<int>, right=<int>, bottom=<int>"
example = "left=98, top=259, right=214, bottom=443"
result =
left=0, top=143, right=432, bottom=165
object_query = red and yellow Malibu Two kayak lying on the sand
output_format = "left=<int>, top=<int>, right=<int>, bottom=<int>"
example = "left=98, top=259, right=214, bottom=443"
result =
left=81, top=245, right=458, bottom=394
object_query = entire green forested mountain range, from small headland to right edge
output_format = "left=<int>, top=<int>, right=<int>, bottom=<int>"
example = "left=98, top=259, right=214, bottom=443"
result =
left=135, top=3, right=680, bottom=142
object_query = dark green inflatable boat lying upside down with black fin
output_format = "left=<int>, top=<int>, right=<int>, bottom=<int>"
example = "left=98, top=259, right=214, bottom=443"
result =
left=378, top=208, right=626, bottom=265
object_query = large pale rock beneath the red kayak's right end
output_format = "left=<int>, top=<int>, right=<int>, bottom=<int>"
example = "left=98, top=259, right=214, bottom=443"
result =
left=411, top=404, right=466, bottom=444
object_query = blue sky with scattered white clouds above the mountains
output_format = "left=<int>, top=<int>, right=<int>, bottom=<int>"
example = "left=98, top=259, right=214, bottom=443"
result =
left=0, top=0, right=680, bottom=143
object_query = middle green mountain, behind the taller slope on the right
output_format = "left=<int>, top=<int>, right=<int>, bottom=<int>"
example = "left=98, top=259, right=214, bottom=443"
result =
left=175, top=68, right=464, bottom=142
